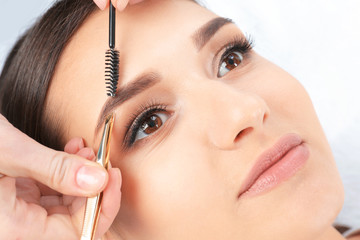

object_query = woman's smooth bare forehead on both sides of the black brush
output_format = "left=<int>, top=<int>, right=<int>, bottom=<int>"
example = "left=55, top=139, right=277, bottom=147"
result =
left=48, top=0, right=215, bottom=146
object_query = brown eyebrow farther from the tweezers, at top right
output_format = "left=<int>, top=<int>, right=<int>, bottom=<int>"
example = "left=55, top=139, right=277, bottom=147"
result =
left=192, top=17, right=234, bottom=51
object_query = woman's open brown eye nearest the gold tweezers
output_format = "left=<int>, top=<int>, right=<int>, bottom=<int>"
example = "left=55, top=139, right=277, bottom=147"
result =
left=134, top=112, right=169, bottom=142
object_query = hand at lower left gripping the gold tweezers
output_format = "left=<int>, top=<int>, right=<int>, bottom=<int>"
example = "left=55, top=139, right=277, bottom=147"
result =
left=0, top=115, right=121, bottom=240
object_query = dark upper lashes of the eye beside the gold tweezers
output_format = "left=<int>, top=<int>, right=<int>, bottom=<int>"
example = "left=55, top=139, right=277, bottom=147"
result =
left=124, top=101, right=167, bottom=148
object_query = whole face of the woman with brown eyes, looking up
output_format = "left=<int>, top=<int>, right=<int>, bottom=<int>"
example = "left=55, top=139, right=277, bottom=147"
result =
left=47, top=0, right=343, bottom=240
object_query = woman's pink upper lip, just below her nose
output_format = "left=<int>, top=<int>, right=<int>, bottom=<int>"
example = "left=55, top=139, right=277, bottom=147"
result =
left=238, top=133, right=303, bottom=197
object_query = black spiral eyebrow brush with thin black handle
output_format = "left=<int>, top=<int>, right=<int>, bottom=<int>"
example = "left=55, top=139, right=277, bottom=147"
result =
left=105, top=1, right=120, bottom=97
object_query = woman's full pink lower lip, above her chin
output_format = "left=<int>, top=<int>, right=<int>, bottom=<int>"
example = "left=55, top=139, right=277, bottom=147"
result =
left=240, top=143, right=310, bottom=197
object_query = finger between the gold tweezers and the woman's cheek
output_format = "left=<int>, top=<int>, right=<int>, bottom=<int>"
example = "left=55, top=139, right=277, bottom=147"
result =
left=95, top=168, right=122, bottom=239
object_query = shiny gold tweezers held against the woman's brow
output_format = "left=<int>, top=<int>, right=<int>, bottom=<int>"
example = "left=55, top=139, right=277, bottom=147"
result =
left=80, top=114, right=114, bottom=240
